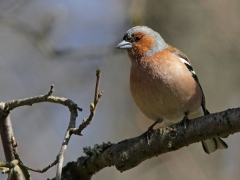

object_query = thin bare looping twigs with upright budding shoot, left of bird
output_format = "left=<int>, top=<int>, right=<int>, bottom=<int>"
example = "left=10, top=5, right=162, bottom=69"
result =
left=0, top=69, right=103, bottom=180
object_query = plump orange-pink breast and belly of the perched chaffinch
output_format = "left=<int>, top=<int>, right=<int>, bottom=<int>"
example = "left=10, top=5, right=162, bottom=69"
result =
left=130, top=50, right=202, bottom=121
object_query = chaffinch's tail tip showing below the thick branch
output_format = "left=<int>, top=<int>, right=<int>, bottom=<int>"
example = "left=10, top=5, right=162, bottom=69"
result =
left=202, top=137, right=228, bottom=154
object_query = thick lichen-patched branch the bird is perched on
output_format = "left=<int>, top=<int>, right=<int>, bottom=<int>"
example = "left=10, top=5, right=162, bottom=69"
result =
left=56, top=108, right=240, bottom=180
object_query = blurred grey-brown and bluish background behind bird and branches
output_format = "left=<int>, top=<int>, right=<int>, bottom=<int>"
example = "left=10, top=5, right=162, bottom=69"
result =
left=0, top=0, right=240, bottom=180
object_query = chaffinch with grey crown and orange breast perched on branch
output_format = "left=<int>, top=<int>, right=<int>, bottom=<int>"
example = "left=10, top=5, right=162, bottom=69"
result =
left=117, top=26, right=228, bottom=154
